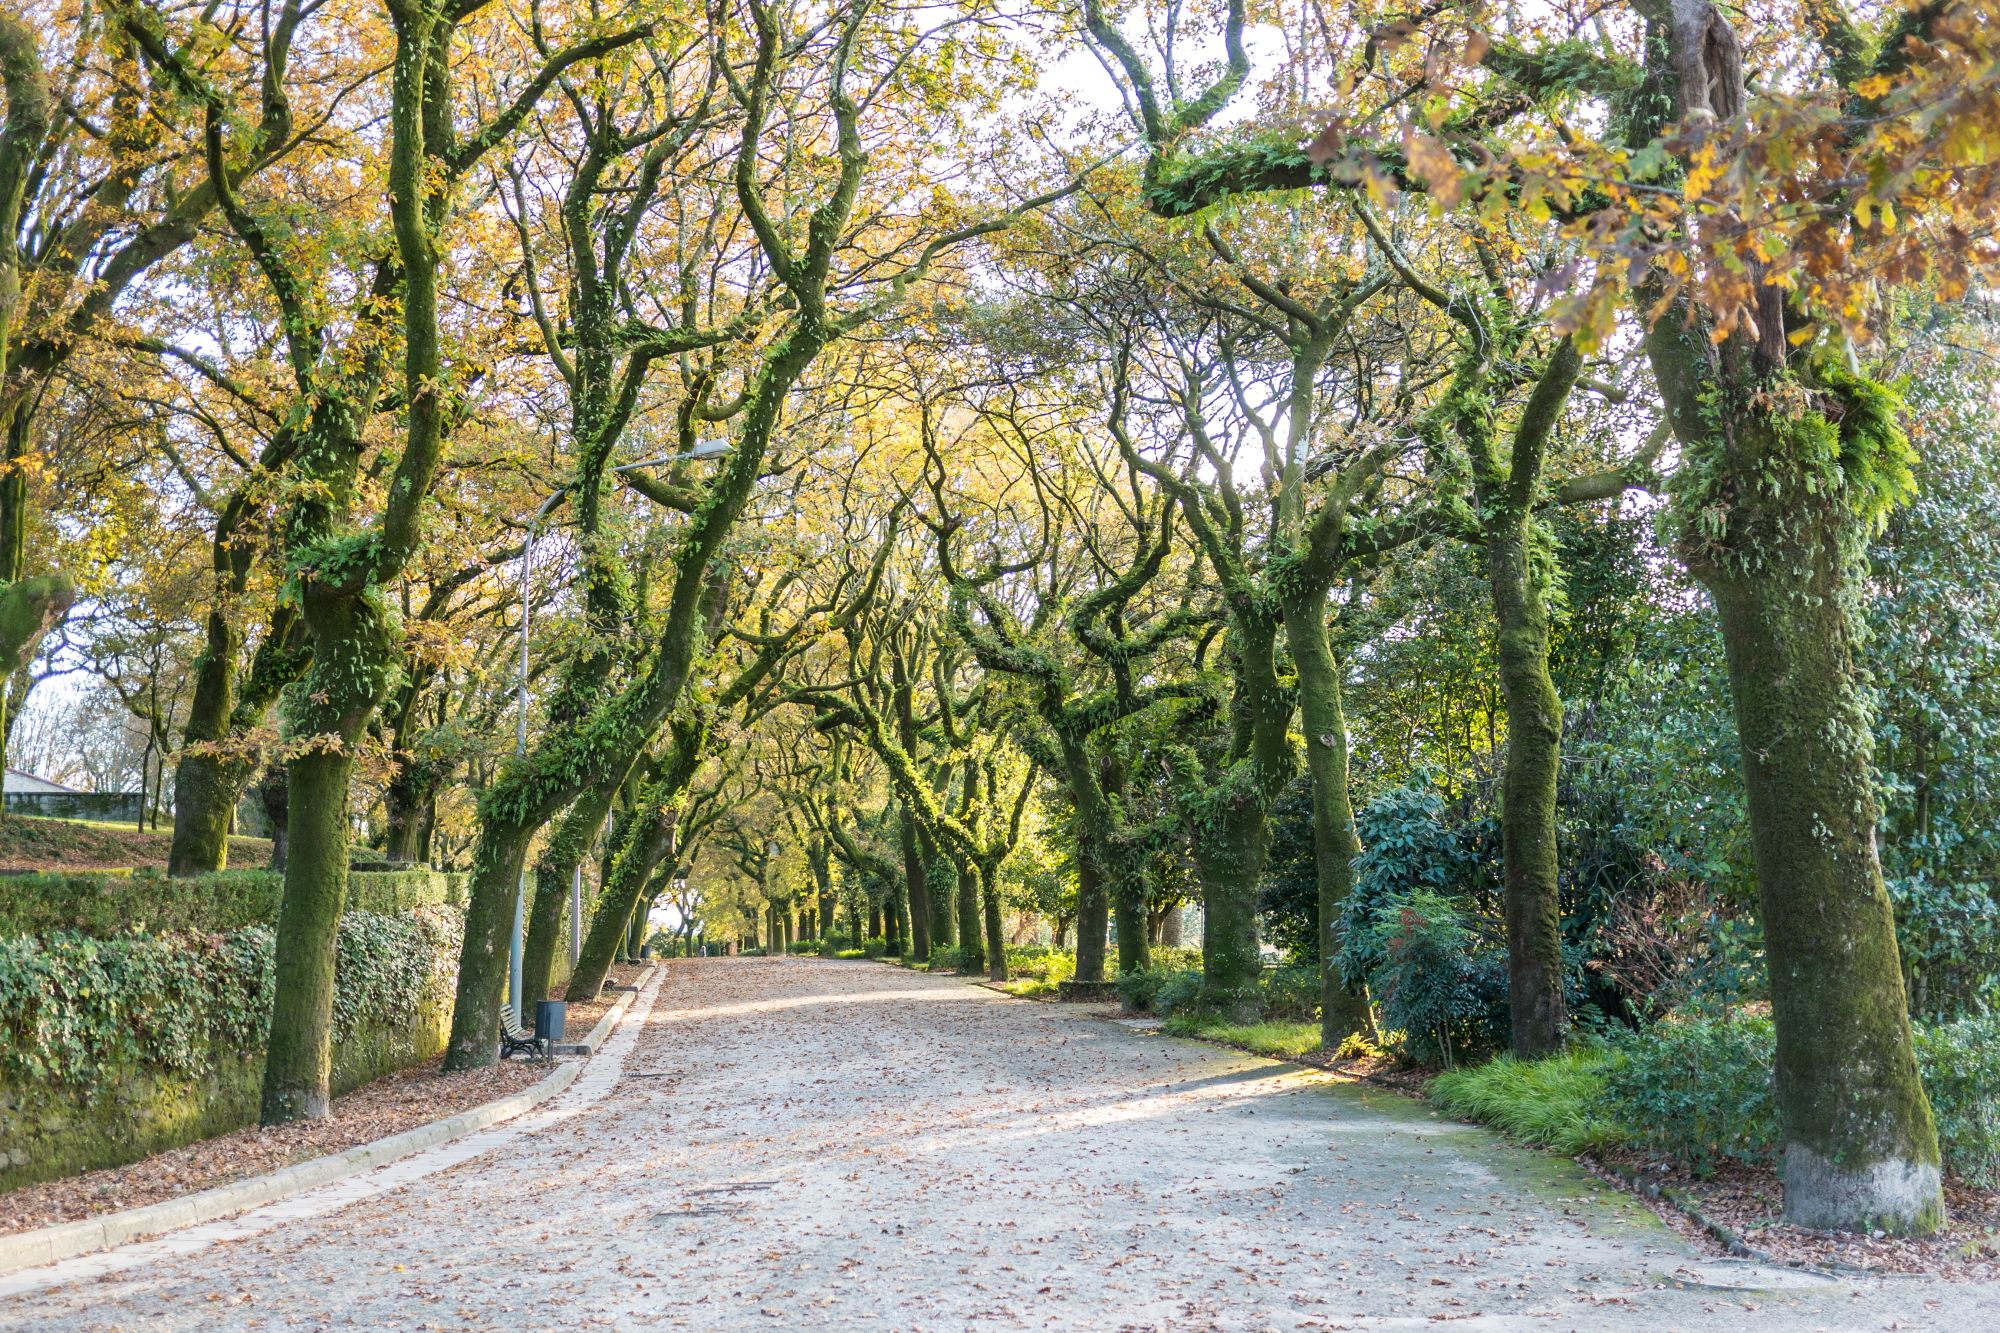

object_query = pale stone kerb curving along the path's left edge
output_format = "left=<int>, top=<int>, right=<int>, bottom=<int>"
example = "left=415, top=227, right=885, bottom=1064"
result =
left=0, top=964, right=656, bottom=1275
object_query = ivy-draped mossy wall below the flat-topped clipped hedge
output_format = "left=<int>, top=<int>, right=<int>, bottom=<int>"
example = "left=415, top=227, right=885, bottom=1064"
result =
left=0, top=905, right=464, bottom=1189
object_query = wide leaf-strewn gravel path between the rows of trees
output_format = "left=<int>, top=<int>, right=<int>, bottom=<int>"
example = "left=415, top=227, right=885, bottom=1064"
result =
left=0, top=959, right=2000, bottom=1333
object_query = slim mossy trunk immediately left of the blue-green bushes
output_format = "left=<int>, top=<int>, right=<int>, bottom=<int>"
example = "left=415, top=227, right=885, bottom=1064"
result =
left=1284, top=588, right=1374, bottom=1051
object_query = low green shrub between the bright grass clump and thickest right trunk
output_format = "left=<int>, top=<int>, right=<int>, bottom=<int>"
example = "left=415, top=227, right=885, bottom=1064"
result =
left=1604, top=1011, right=1778, bottom=1175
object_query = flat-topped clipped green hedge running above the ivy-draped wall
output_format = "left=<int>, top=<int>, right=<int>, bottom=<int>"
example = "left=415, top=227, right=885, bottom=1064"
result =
left=0, top=871, right=466, bottom=939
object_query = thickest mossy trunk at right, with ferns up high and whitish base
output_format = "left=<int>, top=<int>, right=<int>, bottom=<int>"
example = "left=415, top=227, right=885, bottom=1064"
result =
left=1624, top=0, right=1946, bottom=1235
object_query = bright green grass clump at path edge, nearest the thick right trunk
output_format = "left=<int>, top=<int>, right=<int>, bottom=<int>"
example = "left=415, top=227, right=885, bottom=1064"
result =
left=1430, top=1049, right=1628, bottom=1157
